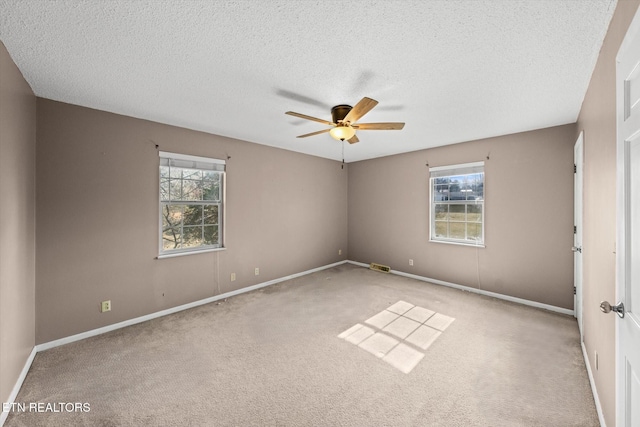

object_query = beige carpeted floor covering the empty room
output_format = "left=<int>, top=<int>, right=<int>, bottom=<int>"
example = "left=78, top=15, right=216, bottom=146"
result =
left=5, top=264, right=599, bottom=427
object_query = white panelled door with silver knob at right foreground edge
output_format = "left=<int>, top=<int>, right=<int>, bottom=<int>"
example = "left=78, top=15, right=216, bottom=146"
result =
left=615, top=10, right=640, bottom=427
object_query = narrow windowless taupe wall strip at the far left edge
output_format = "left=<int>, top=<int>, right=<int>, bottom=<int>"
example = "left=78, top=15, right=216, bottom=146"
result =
left=0, top=42, right=36, bottom=408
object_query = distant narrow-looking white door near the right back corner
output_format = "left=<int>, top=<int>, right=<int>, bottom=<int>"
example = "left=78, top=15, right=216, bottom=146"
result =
left=573, top=132, right=584, bottom=341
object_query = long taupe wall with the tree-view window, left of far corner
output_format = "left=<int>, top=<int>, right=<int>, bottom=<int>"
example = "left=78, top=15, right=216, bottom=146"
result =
left=36, top=99, right=347, bottom=343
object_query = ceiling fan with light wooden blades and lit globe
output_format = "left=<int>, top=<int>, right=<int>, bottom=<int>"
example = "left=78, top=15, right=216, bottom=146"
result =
left=285, top=96, right=404, bottom=144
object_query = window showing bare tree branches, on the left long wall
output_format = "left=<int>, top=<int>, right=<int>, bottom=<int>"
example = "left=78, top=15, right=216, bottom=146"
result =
left=160, top=152, right=225, bottom=257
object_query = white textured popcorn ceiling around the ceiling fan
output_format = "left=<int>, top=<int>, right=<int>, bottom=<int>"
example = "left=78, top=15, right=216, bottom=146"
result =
left=0, top=0, right=616, bottom=161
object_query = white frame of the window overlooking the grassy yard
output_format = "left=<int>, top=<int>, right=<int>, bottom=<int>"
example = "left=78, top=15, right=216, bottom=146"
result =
left=429, top=161, right=486, bottom=248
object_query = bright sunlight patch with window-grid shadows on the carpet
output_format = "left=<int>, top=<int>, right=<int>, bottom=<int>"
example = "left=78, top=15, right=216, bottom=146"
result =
left=338, top=301, right=456, bottom=374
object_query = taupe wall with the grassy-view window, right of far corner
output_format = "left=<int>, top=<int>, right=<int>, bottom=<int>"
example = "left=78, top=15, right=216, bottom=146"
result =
left=349, top=125, right=575, bottom=309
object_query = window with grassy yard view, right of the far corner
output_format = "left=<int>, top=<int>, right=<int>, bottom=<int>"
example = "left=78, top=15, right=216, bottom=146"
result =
left=429, top=162, right=484, bottom=245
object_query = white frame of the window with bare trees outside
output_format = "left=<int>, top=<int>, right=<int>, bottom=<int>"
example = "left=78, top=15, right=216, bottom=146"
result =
left=157, top=151, right=227, bottom=259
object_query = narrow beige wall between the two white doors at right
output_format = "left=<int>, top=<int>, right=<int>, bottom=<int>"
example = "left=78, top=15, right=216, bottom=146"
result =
left=576, top=0, right=640, bottom=426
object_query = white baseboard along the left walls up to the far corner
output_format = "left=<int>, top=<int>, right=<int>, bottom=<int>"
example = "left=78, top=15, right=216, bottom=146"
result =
left=0, top=261, right=347, bottom=427
